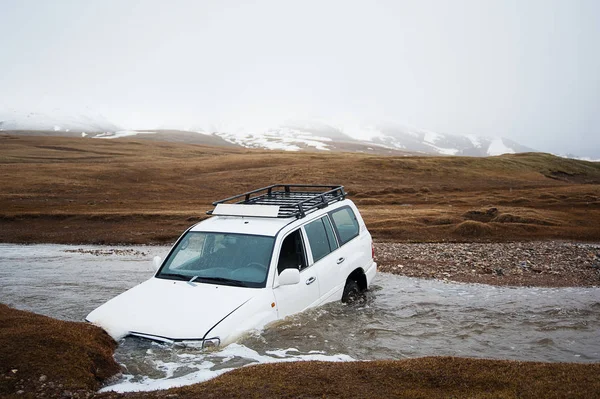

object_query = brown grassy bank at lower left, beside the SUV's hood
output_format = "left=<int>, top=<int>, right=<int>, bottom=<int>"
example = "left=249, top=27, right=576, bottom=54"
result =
left=0, top=304, right=120, bottom=396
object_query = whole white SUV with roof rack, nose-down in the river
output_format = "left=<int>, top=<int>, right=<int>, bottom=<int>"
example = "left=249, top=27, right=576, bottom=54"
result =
left=86, top=184, right=377, bottom=347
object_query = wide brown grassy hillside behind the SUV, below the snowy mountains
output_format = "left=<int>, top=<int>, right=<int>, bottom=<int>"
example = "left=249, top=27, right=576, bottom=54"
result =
left=0, top=135, right=600, bottom=243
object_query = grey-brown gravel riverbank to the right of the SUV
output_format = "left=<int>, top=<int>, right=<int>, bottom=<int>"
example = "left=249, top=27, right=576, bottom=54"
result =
left=375, top=241, right=600, bottom=287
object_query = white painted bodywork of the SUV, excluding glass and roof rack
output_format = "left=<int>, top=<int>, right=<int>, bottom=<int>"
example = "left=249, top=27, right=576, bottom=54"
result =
left=86, top=188, right=377, bottom=346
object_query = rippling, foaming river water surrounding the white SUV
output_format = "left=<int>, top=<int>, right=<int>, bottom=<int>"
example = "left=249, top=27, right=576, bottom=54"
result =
left=0, top=244, right=600, bottom=391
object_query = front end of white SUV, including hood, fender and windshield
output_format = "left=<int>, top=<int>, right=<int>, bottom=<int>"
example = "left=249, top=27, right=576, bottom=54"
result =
left=86, top=230, right=277, bottom=346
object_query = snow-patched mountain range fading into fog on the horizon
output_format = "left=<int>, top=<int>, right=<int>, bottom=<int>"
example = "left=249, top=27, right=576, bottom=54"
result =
left=0, top=110, right=535, bottom=156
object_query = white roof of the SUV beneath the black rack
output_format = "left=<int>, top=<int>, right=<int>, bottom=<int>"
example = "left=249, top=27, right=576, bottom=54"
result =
left=190, top=199, right=350, bottom=237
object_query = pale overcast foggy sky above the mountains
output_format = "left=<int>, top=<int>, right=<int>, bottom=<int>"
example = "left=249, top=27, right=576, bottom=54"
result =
left=0, top=0, right=600, bottom=157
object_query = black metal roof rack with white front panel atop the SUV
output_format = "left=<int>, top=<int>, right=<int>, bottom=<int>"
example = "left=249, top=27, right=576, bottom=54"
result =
left=206, top=184, right=346, bottom=219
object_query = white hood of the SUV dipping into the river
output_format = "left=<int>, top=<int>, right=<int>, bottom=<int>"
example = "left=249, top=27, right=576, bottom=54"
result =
left=86, top=278, right=257, bottom=341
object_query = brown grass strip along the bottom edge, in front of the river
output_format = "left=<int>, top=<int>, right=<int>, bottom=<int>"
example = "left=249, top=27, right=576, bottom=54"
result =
left=132, top=357, right=600, bottom=399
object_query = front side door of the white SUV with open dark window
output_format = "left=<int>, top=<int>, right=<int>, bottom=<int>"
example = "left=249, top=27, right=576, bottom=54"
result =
left=273, top=229, right=319, bottom=318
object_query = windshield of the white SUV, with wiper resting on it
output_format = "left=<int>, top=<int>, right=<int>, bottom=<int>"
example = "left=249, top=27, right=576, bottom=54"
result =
left=156, top=231, right=275, bottom=287
